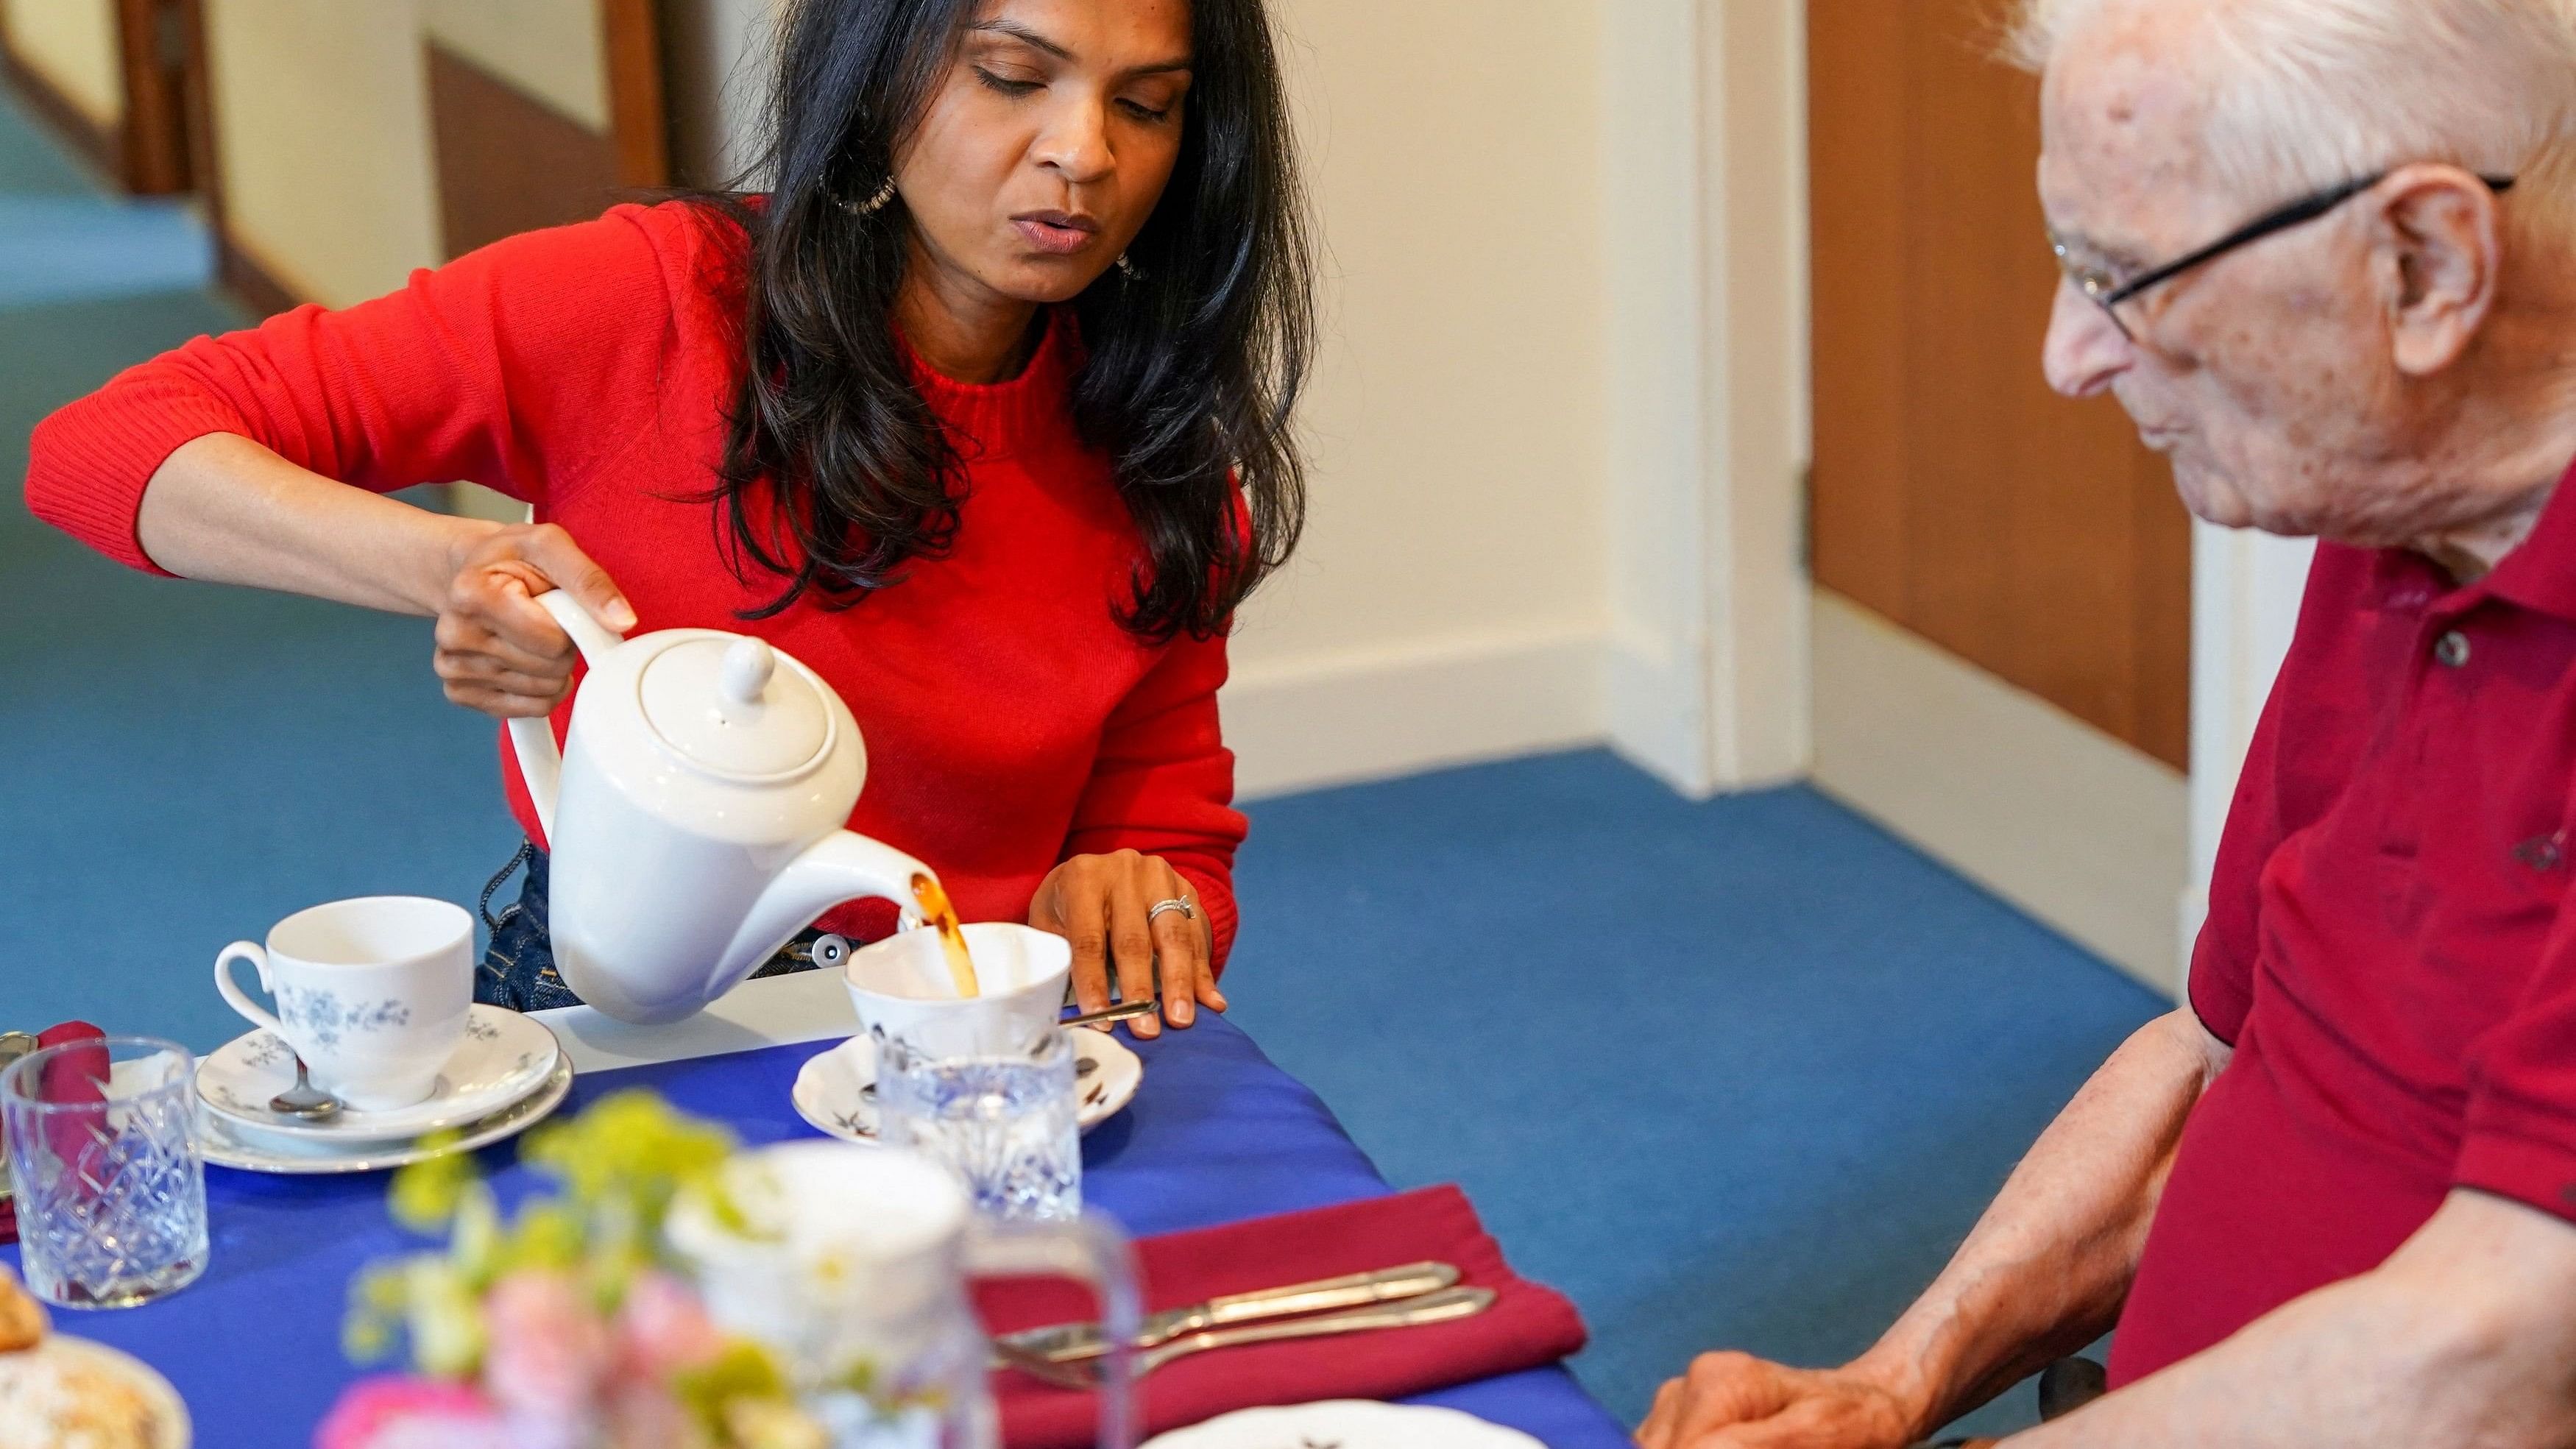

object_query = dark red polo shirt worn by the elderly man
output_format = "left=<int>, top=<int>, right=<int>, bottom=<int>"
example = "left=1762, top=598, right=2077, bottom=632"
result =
left=2112, top=471, right=2576, bottom=1382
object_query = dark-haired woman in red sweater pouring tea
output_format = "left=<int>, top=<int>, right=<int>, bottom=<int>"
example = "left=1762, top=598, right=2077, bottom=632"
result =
left=29, top=0, right=1312, bottom=1035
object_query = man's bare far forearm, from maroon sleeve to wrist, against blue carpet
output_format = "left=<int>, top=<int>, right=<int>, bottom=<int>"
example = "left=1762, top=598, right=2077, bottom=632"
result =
left=1853, top=1009, right=2226, bottom=1434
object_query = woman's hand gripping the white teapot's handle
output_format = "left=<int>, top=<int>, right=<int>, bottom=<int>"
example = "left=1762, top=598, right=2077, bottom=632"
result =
left=436, top=522, right=637, bottom=718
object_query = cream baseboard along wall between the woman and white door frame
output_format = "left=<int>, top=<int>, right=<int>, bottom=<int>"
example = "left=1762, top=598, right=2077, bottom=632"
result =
left=1221, top=631, right=1602, bottom=798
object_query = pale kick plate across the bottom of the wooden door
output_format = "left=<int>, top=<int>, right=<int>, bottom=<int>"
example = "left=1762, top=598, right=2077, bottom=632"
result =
left=1814, top=589, right=2190, bottom=996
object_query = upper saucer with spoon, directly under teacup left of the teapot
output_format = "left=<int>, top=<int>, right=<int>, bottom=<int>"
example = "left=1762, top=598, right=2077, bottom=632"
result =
left=196, top=1006, right=565, bottom=1143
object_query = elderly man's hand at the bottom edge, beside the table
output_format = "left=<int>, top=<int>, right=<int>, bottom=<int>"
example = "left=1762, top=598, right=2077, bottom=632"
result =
left=1636, top=1354, right=1917, bottom=1449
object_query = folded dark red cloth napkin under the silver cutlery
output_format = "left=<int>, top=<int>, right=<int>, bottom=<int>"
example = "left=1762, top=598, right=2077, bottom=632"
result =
left=977, top=1186, right=1585, bottom=1449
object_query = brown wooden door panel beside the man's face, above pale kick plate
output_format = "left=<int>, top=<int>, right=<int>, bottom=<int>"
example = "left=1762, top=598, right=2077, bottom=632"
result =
left=1808, top=0, right=2193, bottom=770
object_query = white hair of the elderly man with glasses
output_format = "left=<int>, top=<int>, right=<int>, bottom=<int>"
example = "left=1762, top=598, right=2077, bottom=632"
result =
left=2007, top=0, right=2576, bottom=211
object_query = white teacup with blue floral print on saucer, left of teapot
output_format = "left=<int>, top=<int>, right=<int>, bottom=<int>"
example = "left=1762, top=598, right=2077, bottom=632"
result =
left=214, top=896, right=474, bottom=1112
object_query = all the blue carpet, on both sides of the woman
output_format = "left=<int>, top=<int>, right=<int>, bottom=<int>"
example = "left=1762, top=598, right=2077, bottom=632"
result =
left=0, top=88, right=2159, bottom=1426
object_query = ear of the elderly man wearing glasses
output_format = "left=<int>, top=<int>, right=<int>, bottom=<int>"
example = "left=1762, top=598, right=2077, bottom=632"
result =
left=2375, top=165, right=2504, bottom=378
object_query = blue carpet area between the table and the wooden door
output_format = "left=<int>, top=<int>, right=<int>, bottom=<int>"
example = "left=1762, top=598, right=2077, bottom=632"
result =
left=1229, top=751, right=2164, bottom=1426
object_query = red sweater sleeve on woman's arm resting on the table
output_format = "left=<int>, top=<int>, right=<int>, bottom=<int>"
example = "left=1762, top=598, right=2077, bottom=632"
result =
left=1064, top=636, right=1245, bottom=973
